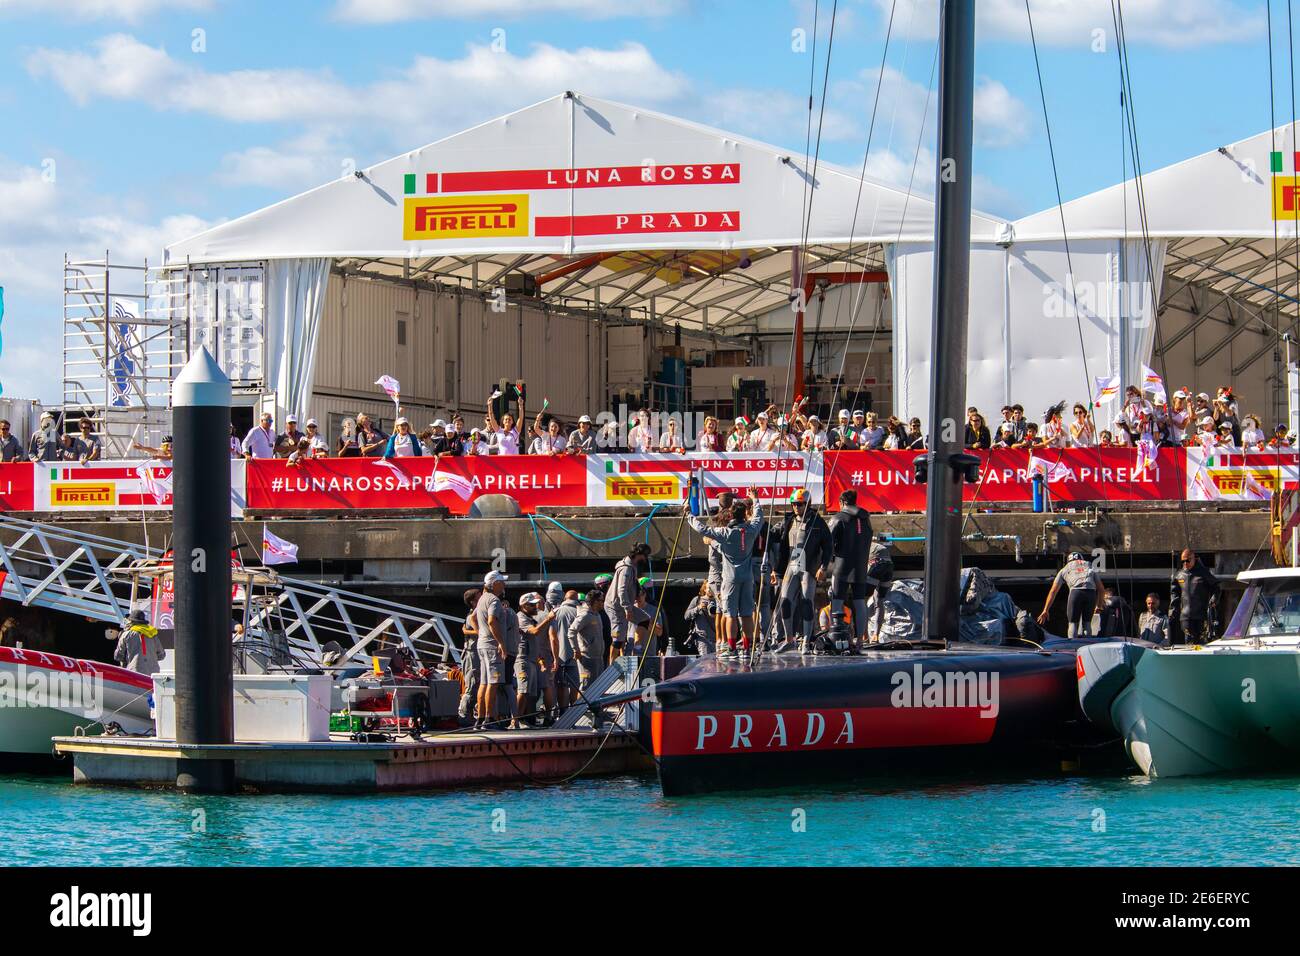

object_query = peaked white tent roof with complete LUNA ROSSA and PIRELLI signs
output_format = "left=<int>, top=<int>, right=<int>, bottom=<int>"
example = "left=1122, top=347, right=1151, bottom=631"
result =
left=165, top=94, right=1006, bottom=328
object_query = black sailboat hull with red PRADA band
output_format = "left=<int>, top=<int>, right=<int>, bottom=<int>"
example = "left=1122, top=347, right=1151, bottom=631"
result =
left=651, top=641, right=1088, bottom=796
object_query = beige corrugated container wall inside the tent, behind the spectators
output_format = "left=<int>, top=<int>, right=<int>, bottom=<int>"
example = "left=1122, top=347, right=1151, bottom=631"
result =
left=312, top=274, right=606, bottom=429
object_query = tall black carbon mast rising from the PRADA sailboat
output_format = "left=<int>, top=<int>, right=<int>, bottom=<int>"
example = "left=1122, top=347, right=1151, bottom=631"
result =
left=918, top=0, right=978, bottom=640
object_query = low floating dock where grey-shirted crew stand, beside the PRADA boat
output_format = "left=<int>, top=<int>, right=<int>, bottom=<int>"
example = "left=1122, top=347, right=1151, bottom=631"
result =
left=55, top=730, right=653, bottom=792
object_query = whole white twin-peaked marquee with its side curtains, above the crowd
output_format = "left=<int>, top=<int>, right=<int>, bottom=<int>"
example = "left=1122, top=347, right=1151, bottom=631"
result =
left=165, top=94, right=1300, bottom=426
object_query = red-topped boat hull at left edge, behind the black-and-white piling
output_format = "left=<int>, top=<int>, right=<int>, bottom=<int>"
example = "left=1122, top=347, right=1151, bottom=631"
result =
left=0, top=648, right=153, bottom=757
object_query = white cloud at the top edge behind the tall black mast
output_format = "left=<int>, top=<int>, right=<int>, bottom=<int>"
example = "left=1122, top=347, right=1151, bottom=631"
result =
left=875, top=0, right=1265, bottom=51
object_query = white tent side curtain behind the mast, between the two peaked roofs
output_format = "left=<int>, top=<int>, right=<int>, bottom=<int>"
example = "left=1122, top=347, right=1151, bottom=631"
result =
left=885, top=239, right=1167, bottom=427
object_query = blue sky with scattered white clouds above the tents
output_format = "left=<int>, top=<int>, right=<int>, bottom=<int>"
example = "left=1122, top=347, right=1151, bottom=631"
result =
left=0, top=0, right=1284, bottom=402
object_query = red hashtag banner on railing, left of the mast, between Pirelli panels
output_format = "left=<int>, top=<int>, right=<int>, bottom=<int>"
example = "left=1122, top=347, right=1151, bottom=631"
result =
left=247, top=455, right=586, bottom=515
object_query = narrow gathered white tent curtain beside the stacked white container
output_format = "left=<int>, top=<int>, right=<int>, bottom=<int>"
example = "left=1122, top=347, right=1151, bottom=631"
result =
left=267, top=259, right=330, bottom=420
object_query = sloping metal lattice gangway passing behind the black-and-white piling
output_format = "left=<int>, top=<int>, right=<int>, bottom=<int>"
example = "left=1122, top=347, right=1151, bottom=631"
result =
left=0, top=515, right=462, bottom=669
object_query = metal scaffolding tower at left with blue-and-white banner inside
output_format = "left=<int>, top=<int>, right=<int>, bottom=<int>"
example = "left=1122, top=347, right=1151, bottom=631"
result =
left=60, top=251, right=189, bottom=458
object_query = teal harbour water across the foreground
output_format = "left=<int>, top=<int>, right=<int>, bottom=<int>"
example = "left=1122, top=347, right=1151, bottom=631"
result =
left=0, top=775, right=1300, bottom=866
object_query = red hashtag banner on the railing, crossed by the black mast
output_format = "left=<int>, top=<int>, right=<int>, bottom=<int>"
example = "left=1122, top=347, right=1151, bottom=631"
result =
left=824, top=447, right=1187, bottom=511
